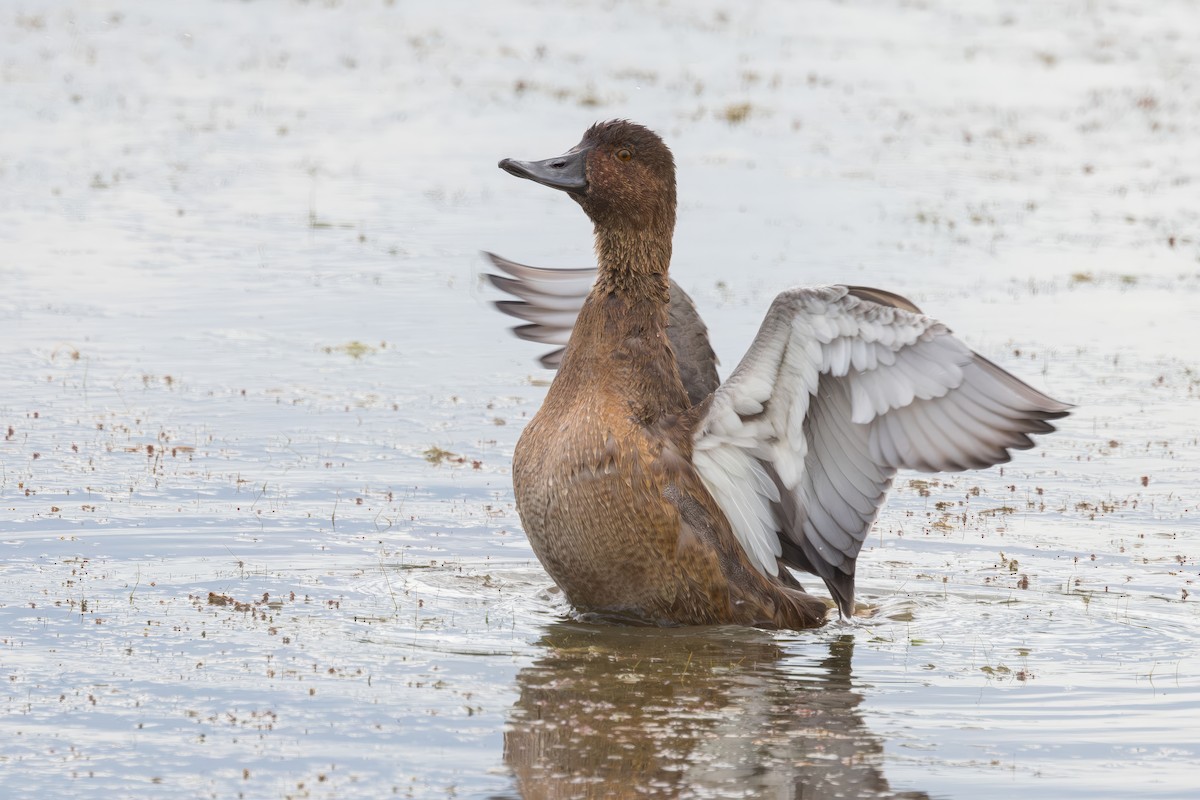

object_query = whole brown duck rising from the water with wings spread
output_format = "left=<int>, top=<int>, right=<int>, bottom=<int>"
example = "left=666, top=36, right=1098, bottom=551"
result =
left=488, top=120, right=1073, bottom=630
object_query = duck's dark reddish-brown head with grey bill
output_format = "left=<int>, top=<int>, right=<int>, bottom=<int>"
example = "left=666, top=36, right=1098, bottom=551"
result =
left=499, top=120, right=676, bottom=230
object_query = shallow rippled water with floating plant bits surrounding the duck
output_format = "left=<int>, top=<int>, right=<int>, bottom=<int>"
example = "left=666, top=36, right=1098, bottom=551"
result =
left=0, top=0, right=1200, bottom=798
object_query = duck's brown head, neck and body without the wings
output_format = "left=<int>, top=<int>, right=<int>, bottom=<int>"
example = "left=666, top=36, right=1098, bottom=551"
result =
left=500, top=121, right=828, bottom=628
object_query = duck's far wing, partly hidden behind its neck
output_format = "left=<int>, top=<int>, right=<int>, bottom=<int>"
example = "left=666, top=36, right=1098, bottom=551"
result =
left=484, top=253, right=720, bottom=405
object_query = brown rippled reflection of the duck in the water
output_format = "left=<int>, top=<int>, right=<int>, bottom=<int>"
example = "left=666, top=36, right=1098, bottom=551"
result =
left=504, top=624, right=928, bottom=798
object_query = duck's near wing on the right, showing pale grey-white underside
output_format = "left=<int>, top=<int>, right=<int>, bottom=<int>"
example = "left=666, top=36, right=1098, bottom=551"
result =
left=694, top=285, right=1072, bottom=616
